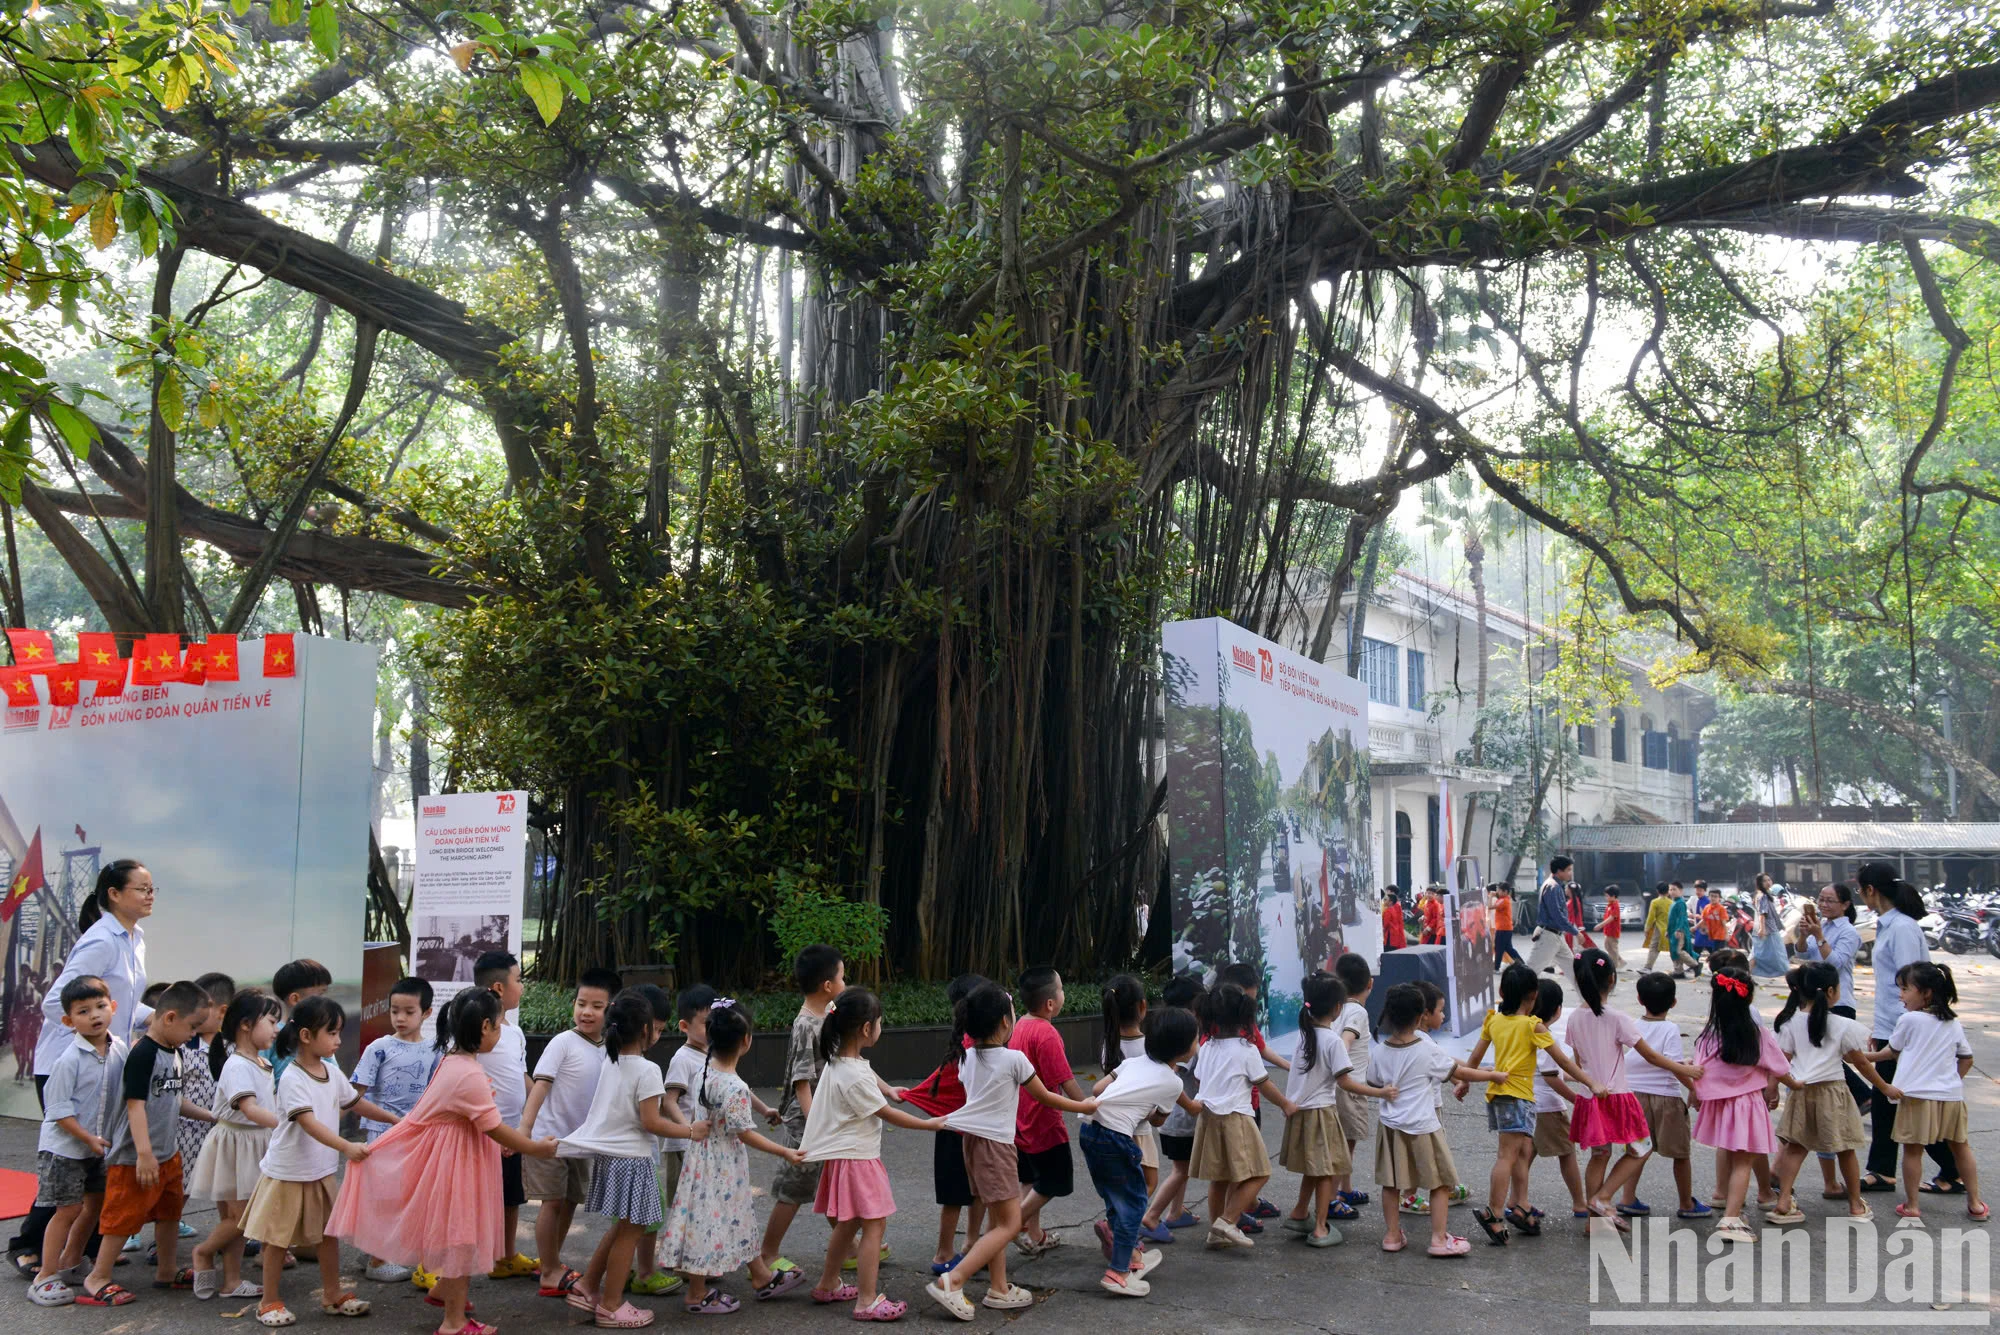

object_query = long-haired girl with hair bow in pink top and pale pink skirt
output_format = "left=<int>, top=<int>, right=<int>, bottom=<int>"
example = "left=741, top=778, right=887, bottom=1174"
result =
left=1694, top=967, right=1792, bottom=1243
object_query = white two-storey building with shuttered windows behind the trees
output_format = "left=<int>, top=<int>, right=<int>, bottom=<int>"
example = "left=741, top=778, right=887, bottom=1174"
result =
left=1286, top=572, right=1714, bottom=889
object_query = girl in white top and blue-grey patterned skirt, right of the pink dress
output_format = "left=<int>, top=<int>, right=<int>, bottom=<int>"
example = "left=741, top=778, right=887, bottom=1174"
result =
left=562, top=989, right=736, bottom=1331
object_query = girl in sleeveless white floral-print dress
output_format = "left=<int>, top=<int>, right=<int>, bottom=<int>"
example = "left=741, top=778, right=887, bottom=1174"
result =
left=660, top=997, right=818, bottom=1325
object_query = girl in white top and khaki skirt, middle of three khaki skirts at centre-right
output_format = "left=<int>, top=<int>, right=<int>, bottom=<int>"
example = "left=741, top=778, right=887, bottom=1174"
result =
left=1278, top=973, right=1396, bottom=1247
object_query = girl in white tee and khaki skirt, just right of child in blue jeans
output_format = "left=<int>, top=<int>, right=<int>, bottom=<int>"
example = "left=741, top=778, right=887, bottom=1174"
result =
left=1188, top=983, right=1294, bottom=1247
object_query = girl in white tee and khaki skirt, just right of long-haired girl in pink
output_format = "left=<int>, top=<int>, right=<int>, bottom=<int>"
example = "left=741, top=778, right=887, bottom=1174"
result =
left=1764, top=963, right=1890, bottom=1223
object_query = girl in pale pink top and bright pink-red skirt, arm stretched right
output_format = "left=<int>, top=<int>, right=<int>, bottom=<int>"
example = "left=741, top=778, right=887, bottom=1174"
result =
left=1564, top=947, right=1702, bottom=1233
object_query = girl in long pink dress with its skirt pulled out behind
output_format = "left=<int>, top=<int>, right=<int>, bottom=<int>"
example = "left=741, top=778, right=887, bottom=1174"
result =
left=326, top=989, right=556, bottom=1335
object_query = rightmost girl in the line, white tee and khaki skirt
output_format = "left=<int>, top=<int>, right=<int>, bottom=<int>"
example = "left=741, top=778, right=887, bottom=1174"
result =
left=1874, top=961, right=1992, bottom=1223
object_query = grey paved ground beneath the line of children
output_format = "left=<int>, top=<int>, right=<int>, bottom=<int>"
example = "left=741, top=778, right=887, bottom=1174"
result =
left=0, top=957, right=2000, bottom=1335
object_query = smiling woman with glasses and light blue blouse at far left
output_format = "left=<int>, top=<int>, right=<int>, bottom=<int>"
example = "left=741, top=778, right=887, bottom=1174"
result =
left=8, top=857, right=154, bottom=1277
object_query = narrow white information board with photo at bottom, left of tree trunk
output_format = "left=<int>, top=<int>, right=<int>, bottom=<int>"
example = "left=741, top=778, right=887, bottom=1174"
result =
left=410, top=791, right=528, bottom=1017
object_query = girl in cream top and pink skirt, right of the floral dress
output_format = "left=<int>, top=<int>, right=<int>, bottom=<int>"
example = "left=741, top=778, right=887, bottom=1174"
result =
left=798, top=987, right=944, bottom=1321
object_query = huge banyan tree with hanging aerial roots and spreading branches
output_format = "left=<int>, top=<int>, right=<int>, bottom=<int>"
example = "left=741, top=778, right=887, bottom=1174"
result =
left=4, top=0, right=2000, bottom=975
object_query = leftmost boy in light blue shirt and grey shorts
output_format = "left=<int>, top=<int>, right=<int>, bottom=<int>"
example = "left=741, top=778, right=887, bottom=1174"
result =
left=28, top=973, right=126, bottom=1307
